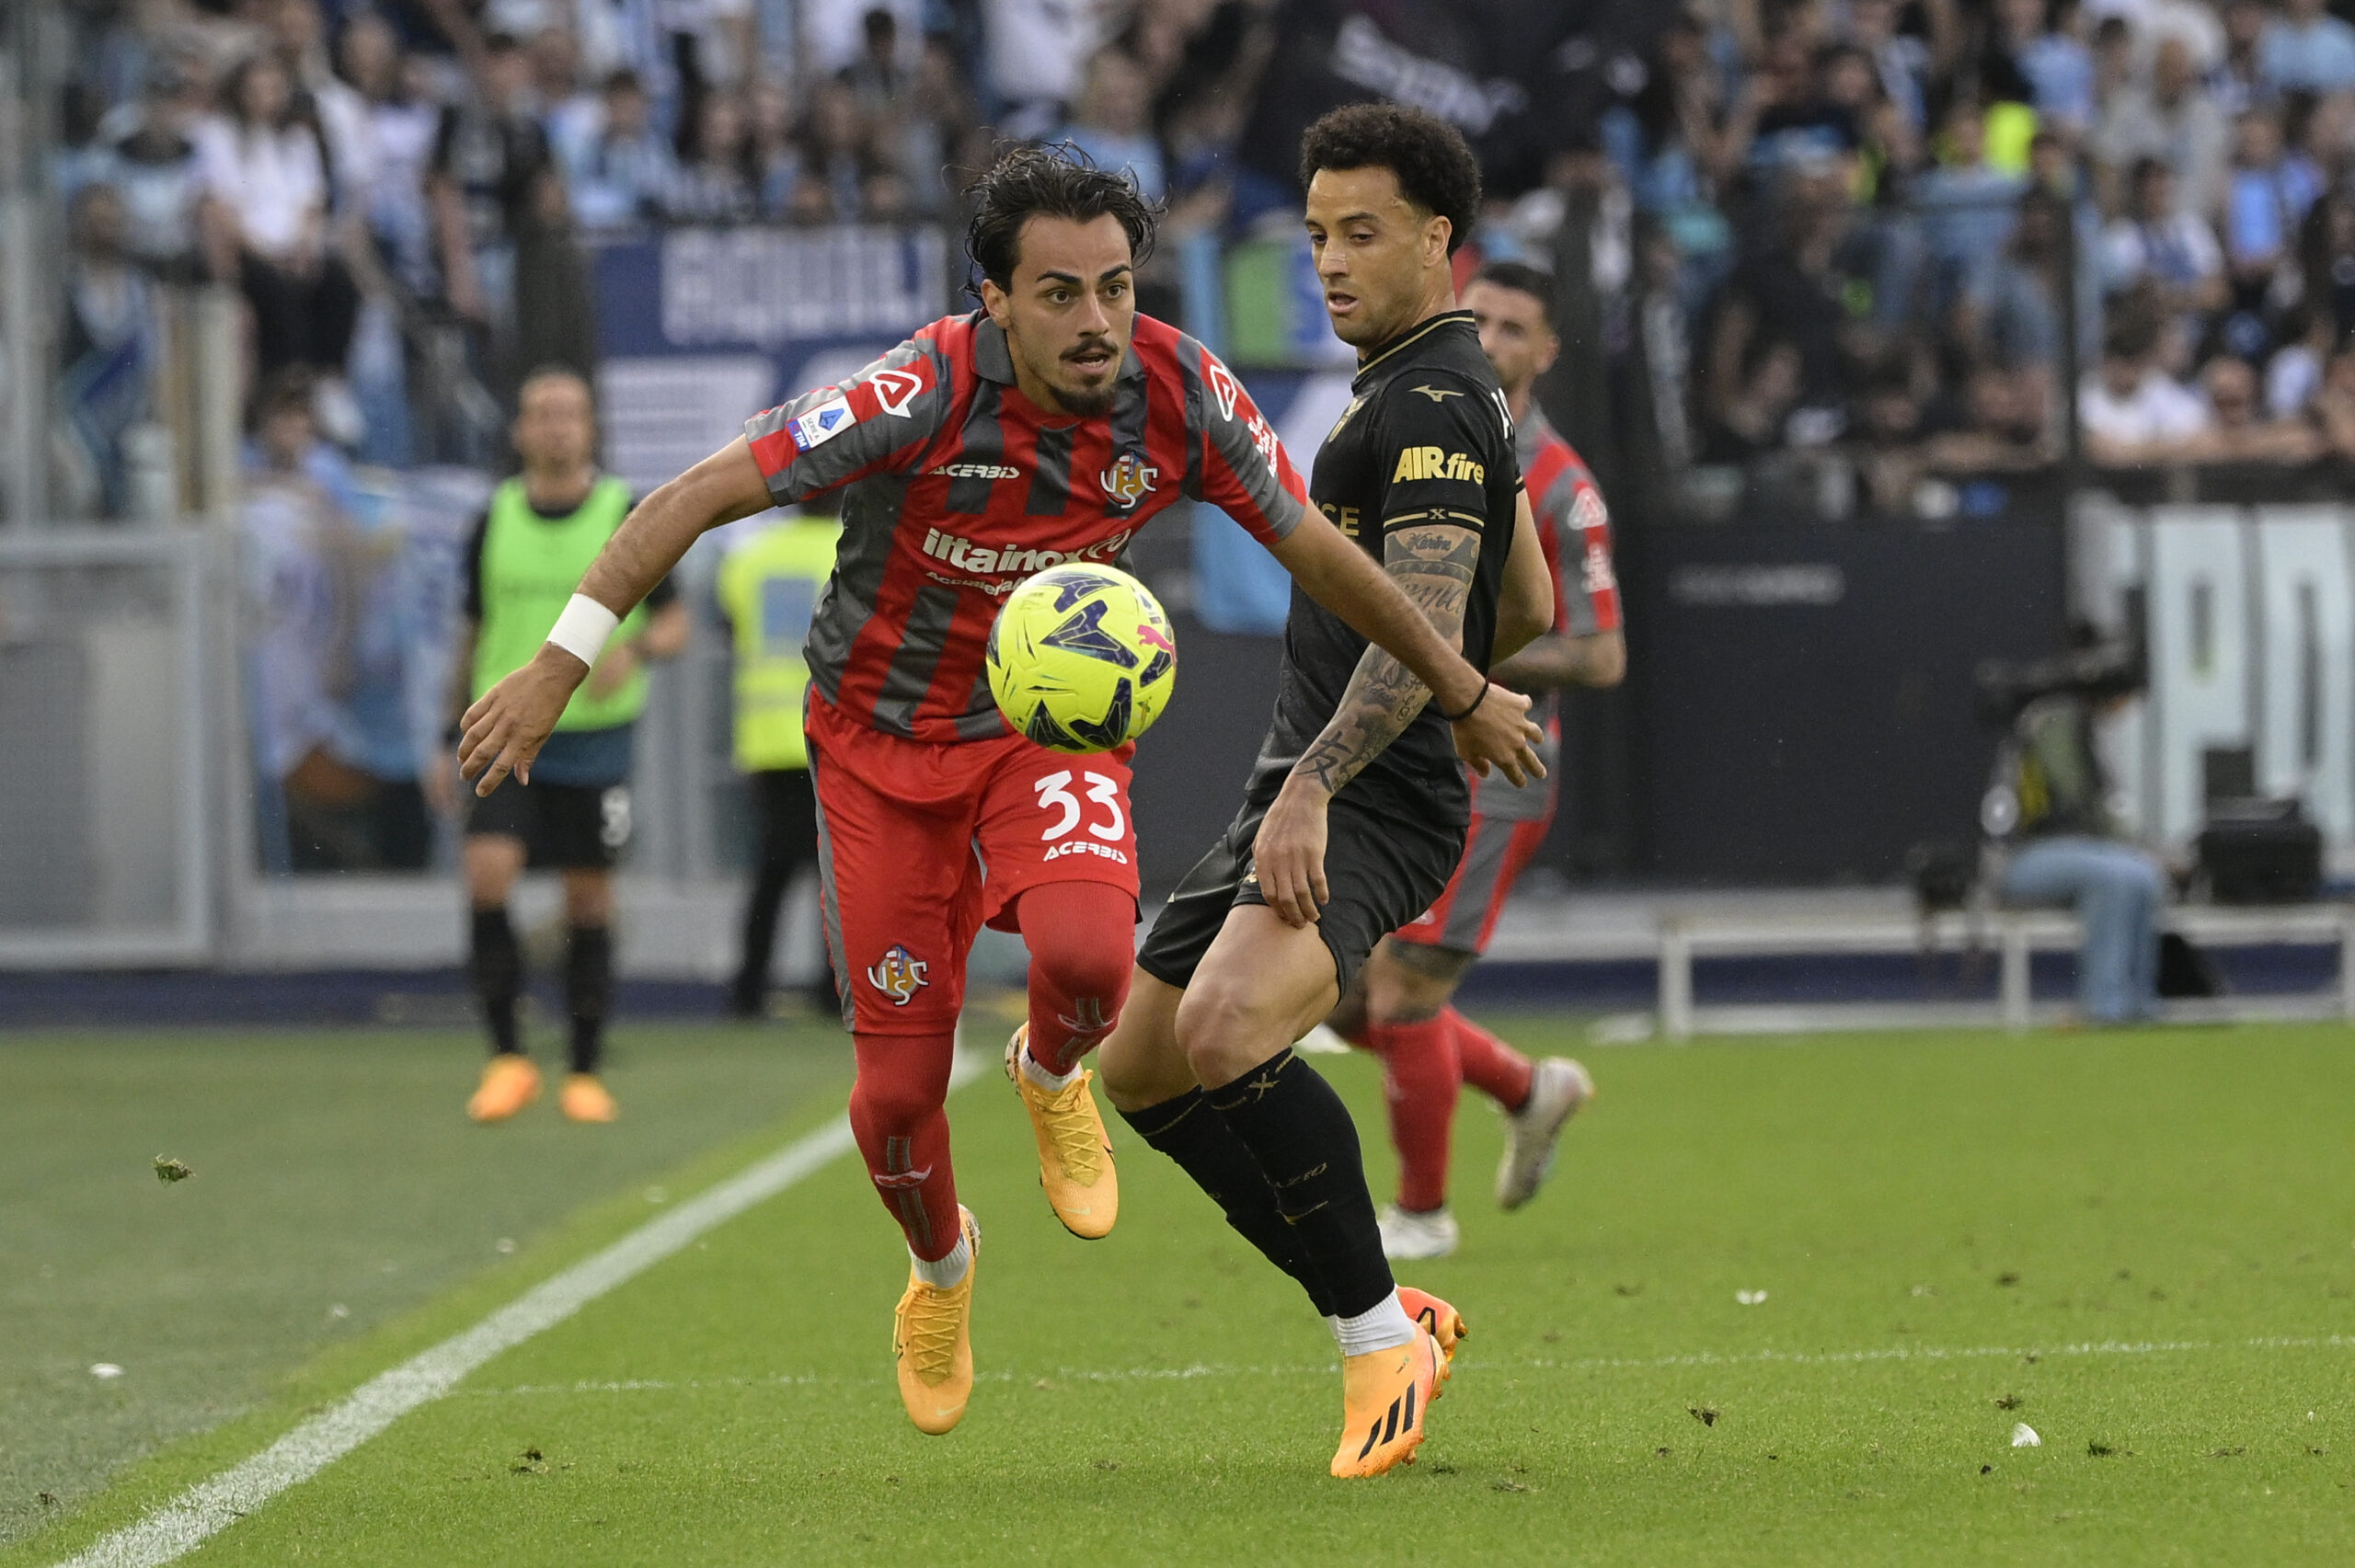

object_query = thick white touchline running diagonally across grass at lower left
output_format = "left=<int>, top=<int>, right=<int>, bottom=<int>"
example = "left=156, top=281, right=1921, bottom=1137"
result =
left=62, top=1052, right=980, bottom=1568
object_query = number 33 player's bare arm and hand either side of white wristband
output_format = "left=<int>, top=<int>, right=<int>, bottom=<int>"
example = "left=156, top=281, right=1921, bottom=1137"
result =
left=457, top=438, right=770, bottom=795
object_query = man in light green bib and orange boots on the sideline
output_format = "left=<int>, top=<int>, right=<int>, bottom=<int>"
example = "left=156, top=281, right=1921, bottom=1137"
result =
left=442, top=370, right=688, bottom=1121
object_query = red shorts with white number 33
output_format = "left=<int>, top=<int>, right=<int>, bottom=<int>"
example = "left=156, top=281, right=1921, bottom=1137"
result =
left=808, top=690, right=1137, bottom=1034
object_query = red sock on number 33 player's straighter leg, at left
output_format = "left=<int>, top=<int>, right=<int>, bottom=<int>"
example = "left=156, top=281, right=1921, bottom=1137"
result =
left=850, top=1034, right=959, bottom=1262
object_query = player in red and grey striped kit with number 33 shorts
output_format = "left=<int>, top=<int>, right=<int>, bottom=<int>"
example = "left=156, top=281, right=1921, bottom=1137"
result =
left=459, top=148, right=1543, bottom=1434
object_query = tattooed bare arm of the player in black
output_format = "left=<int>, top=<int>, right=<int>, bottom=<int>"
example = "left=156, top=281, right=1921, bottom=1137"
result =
left=1253, top=522, right=1488, bottom=925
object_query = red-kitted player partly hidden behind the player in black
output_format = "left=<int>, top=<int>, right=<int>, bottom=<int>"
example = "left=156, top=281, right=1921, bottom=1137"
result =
left=1333, top=261, right=1627, bottom=1260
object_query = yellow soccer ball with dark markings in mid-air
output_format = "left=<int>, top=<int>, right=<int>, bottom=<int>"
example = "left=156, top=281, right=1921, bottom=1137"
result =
left=989, top=560, right=1178, bottom=753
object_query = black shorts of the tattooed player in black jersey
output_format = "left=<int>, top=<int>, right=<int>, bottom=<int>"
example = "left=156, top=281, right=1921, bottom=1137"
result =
left=1137, top=789, right=1465, bottom=993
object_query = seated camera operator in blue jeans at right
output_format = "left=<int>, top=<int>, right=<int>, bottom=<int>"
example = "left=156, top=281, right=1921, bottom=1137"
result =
left=1981, top=643, right=2166, bottom=1024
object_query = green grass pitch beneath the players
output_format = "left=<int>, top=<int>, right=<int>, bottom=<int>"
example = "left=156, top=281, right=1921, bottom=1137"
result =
left=0, top=1020, right=2355, bottom=1568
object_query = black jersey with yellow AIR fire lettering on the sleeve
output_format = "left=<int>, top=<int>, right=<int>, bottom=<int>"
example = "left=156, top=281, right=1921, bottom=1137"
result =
left=1250, top=311, right=1522, bottom=827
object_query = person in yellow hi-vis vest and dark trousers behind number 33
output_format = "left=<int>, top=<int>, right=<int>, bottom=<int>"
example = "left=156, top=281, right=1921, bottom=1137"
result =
left=718, top=503, right=843, bottom=1017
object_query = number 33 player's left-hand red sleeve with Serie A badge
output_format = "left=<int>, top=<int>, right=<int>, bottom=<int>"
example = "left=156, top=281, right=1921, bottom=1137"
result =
left=744, top=337, right=956, bottom=506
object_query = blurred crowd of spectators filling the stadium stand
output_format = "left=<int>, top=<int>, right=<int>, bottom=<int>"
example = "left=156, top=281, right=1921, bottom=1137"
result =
left=45, top=0, right=2355, bottom=522
